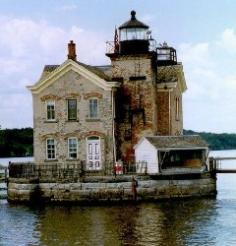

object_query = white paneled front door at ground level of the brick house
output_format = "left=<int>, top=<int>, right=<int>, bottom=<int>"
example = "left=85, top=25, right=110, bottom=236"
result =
left=87, top=137, right=102, bottom=170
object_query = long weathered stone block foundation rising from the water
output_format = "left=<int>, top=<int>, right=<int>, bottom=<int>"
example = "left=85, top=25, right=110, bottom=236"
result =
left=8, top=173, right=216, bottom=202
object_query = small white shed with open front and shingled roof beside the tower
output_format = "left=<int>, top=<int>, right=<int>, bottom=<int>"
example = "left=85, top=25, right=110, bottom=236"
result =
left=134, top=135, right=208, bottom=174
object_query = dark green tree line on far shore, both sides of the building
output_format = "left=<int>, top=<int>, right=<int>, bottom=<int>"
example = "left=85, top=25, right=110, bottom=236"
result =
left=0, top=127, right=236, bottom=157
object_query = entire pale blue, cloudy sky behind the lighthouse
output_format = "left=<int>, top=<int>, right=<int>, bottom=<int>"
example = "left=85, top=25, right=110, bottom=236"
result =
left=0, top=0, right=236, bottom=133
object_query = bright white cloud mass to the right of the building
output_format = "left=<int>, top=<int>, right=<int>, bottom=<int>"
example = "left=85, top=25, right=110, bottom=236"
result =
left=178, top=31, right=236, bottom=132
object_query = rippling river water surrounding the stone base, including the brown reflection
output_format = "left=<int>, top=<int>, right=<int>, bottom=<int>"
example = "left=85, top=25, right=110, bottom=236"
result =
left=0, top=150, right=236, bottom=246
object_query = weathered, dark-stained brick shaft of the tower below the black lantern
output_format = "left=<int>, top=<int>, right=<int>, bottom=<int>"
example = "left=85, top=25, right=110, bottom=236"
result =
left=112, top=54, right=157, bottom=162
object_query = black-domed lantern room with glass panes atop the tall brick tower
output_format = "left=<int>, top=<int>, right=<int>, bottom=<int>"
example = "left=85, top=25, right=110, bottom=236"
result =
left=119, top=11, right=150, bottom=54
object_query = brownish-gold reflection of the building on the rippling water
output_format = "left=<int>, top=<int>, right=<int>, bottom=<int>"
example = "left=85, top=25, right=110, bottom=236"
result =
left=35, top=199, right=216, bottom=246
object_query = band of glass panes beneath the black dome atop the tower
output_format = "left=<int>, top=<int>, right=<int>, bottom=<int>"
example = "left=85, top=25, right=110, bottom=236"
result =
left=120, top=28, right=147, bottom=41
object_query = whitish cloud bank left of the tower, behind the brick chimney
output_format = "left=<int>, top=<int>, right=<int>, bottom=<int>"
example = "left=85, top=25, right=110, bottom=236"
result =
left=0, top=16, right=106, bottom=128
